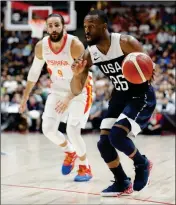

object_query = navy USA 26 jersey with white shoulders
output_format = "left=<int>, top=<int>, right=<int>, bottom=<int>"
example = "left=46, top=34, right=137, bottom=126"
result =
left=88, top=33, right=149, bottom=97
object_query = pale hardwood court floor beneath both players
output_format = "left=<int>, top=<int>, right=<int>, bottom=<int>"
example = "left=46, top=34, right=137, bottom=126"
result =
left=1, top=133, right=175, bottom=205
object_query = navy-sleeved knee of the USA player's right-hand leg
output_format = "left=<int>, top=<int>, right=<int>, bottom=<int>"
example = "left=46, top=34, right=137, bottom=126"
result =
left=109, top=119, right=131, bottom=148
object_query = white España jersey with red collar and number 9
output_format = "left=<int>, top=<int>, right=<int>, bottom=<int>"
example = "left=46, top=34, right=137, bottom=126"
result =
left=42, top=34, right=90, bottom=95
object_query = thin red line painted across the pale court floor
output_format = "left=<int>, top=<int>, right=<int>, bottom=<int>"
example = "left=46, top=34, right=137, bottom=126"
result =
left=1, top=184, right=175, bottom=205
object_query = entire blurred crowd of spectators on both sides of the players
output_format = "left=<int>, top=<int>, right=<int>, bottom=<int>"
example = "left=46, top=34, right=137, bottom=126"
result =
left=1, top=2, right=176, bottom=134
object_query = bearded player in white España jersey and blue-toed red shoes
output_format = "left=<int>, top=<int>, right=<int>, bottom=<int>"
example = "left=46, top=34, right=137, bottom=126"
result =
left=20, top=14, right=92, bottom=181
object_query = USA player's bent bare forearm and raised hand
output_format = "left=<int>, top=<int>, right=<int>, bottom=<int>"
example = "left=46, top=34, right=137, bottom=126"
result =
left=70, top=49, right=92, bottom=95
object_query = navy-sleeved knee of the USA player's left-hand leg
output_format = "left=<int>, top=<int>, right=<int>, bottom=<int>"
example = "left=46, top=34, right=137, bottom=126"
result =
left=97, top=135, right=117, bottom=163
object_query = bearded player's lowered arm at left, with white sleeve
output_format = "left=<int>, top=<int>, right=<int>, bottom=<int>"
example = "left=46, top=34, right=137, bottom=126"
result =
left=19, top=41, right=45, bottom=113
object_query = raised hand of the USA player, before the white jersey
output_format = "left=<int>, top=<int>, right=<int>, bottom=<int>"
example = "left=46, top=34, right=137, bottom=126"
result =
left=71, top=58, right=87, bottom=75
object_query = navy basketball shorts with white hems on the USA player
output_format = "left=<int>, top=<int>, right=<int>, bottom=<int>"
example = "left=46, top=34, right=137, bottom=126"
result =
left=100, top=86, right=156, bottom=136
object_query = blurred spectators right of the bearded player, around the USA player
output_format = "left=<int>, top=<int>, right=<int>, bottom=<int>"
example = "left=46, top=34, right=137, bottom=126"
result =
left=89, top=2, right=176, bottom=133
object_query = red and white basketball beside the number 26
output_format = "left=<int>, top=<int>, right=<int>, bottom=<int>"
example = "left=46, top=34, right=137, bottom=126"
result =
left=122, top=52, right=153, bottom=84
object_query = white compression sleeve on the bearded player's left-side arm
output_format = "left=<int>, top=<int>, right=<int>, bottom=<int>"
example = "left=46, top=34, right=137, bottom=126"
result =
left=27, top=56, right=45, bottom=83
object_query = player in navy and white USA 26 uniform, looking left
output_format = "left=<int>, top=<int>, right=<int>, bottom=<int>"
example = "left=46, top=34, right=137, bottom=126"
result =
left=71, top=10, right=156, bottom=196
